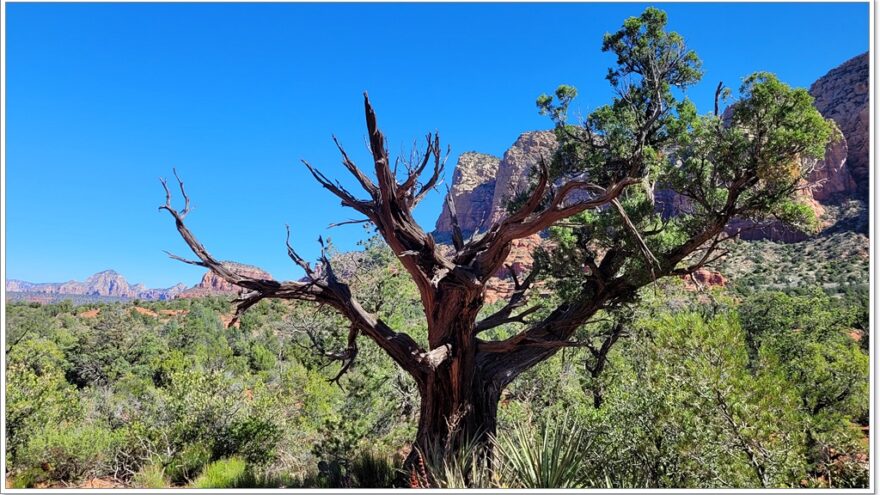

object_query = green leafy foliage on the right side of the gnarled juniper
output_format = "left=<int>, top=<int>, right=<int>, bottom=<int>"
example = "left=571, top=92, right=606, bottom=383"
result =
left=528, top=8, right=837, bottom=302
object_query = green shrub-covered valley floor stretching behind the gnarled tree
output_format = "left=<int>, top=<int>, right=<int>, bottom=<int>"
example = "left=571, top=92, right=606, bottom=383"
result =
left=6, top=235, right=868, bottom=488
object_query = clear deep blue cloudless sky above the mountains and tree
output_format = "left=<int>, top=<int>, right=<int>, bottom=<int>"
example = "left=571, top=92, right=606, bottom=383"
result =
left=5, top=3, right=869, bottom=287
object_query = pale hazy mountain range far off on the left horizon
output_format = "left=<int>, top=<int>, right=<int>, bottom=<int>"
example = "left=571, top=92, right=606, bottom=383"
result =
left=6, top=270, right=186, bottom=300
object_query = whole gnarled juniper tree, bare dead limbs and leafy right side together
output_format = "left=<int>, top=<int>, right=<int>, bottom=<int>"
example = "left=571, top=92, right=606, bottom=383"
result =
left=161, top=9, right=830, bottom=472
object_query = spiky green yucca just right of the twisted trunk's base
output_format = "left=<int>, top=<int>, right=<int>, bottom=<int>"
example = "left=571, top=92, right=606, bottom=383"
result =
left=493, top=419, right=590, bottom=488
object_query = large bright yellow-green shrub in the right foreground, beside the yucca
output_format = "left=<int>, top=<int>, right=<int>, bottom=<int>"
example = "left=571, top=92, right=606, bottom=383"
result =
left=499, top=305, right=806, bottom=488
